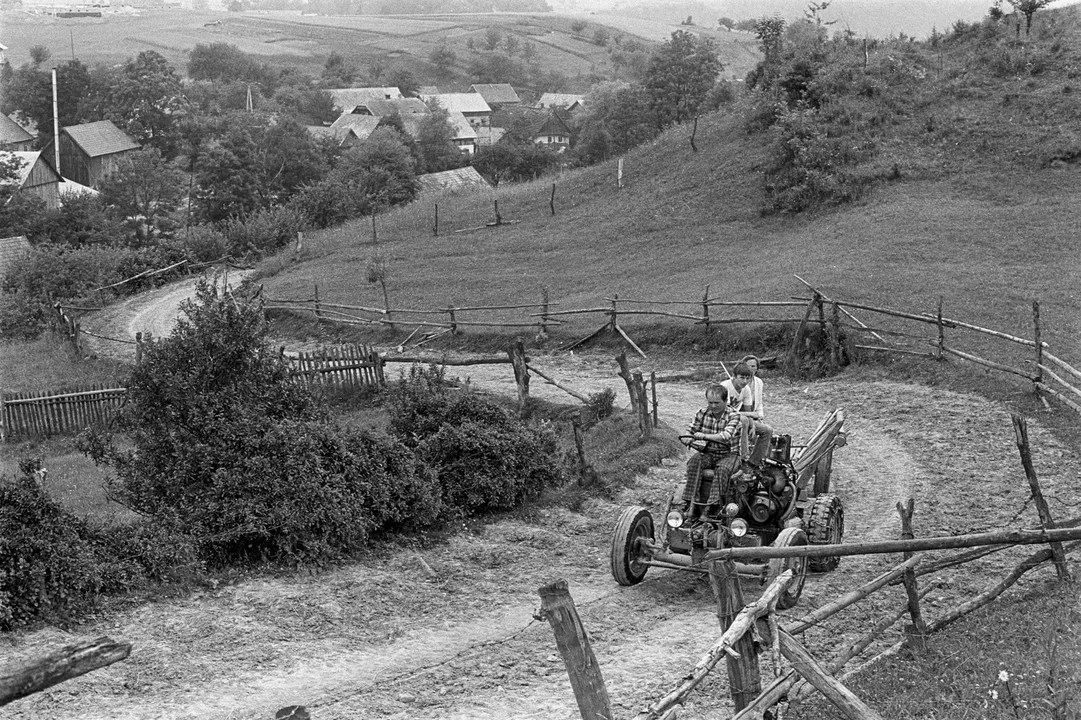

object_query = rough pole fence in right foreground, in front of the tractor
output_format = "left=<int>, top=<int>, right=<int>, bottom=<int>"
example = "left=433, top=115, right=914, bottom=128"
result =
left=538, top=415, right=1081, bottom=720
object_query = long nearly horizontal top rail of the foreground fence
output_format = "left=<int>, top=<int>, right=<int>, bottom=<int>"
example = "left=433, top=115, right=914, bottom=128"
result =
left=705, top=528, right=1081, bottom=560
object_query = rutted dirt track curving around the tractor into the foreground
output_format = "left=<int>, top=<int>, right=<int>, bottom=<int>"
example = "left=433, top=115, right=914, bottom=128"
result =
left=4, top=281, right=1079, bottom=720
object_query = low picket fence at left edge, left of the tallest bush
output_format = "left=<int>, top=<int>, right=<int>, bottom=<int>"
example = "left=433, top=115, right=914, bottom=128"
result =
left=0, top=385, right=128, bottom=441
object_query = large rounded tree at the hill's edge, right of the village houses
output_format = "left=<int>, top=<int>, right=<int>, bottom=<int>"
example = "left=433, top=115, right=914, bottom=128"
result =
left=644, top=30, right=722, bottom=124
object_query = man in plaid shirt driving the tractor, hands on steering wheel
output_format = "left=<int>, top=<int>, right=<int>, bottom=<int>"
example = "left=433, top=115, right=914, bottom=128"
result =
left=683, top=385, right=740, bottom=515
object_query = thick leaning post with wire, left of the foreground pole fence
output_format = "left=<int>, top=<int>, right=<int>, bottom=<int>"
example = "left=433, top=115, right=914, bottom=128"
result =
left=537, top=579, right=614, bottom=720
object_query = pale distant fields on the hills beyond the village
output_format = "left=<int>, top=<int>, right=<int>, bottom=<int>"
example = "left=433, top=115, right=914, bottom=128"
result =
left=0, top=9, right=756, bottom=92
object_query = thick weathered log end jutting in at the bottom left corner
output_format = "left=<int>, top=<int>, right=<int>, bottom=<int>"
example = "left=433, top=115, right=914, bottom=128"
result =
left=0, top=637, right=132, bottom=705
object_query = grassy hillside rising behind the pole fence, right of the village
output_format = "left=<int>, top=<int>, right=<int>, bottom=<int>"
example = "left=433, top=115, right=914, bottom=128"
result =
left=257, top=9, right=1081, bottom=369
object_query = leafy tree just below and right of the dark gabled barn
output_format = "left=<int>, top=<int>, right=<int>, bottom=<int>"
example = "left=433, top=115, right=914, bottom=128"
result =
left=101, top=147, right=186, bottom=245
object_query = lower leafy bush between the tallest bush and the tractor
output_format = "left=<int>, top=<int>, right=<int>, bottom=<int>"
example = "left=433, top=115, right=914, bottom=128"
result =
left=388, top=365, right=564, bottom=514
